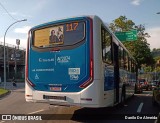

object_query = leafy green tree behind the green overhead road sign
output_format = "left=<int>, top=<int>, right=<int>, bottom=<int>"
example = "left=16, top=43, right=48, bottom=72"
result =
left=109, top=16, right=154, bottom=68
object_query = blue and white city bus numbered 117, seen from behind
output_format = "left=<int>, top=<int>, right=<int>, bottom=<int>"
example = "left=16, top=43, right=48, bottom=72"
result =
left=25, top=16, right=137, bottom=107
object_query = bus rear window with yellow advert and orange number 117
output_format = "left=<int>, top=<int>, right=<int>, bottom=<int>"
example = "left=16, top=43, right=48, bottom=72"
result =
left=32, top=21, right=85, bottom=48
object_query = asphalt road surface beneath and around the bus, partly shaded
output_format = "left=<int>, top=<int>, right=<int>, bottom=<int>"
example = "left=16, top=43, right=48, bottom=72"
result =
left=0, top=83, right=160, bottom=123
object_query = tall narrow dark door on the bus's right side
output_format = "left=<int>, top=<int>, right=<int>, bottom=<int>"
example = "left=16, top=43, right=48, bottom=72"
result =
left=113, top=42, right=119, bottom=104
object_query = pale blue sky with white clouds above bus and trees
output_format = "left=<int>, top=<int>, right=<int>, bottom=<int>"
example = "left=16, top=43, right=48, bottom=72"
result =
left=0, top=0, right=160, bottom=50
